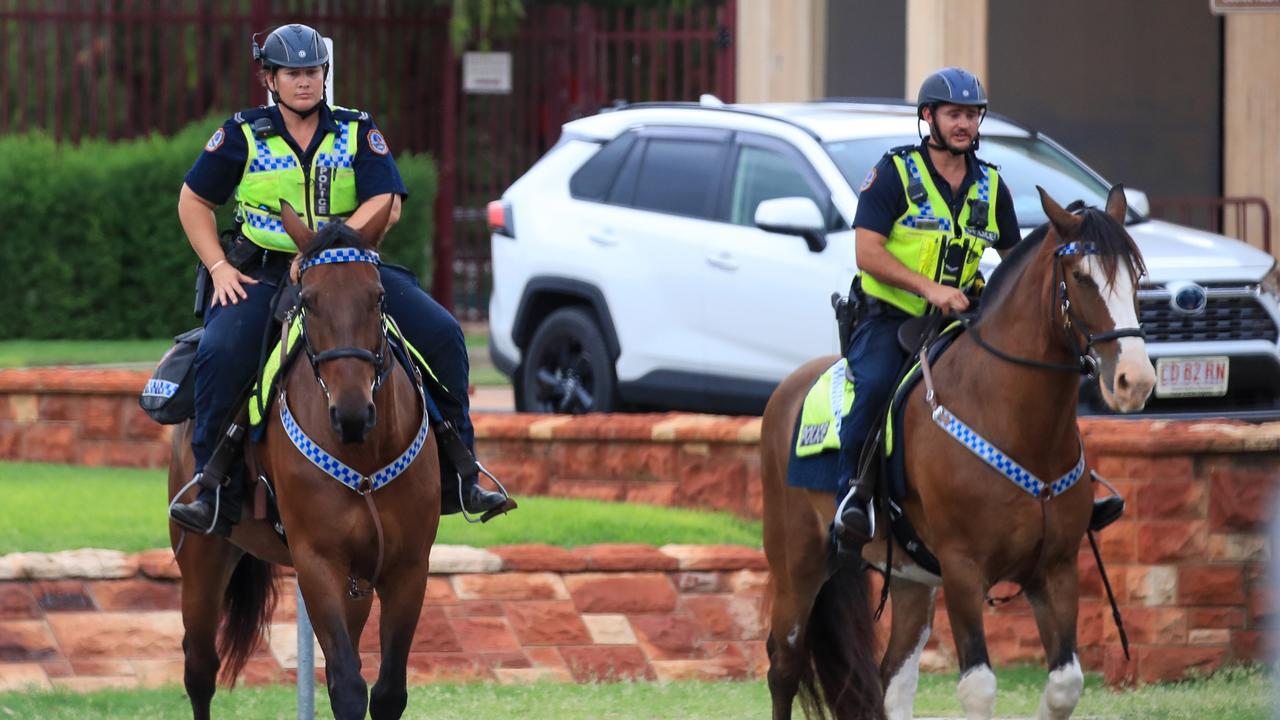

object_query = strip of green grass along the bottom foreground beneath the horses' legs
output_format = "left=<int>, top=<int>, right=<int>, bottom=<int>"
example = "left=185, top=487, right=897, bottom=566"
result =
left=0, top=667, right=1272, bottom=720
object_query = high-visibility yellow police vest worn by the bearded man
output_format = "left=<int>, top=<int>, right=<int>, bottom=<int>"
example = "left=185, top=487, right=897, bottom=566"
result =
left=861, top=147, right=1000, bottom=316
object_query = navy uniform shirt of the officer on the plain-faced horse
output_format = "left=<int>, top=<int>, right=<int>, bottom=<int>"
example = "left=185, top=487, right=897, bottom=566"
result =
left=184, top=104, right=408, bottom=205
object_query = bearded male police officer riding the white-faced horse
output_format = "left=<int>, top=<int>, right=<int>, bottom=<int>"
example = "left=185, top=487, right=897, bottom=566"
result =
left=835, top=68, right=1021, bottom=552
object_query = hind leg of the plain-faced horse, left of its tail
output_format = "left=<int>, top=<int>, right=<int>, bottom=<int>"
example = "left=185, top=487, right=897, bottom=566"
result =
left=178, top=533, right=241, bottom=720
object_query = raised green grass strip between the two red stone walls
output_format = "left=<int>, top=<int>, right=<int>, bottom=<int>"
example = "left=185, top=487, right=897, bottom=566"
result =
left=0, top=462, right=760, bottom=555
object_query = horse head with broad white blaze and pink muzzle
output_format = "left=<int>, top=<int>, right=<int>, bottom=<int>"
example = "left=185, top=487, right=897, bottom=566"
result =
left=1037, top=184, right=1156, bottom=413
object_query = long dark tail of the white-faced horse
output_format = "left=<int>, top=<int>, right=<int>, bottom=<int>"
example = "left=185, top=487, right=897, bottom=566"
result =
left=800, top=566, right=884, bottom=720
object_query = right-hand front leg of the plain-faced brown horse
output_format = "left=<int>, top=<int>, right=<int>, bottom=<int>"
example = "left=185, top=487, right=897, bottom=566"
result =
left=369, top=566, right=426, bottom=720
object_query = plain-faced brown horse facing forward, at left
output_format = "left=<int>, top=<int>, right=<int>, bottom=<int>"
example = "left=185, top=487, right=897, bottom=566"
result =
left=169, top=204, right=440, bottom=719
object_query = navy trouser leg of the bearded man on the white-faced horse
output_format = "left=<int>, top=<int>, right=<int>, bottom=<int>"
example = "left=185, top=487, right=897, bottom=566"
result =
left=831, top=314, right=906, bottom=502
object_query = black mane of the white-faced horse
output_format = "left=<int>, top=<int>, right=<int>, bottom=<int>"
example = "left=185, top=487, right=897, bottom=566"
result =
left=982, top=200, right=1147, bottom=315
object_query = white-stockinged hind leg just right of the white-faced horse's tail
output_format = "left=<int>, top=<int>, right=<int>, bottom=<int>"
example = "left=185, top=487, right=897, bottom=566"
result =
left=881, top=575, right=937, bottom=720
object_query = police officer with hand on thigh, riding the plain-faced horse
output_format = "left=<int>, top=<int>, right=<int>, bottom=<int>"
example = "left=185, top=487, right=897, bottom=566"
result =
left=169, top=24, right=506, bottom=534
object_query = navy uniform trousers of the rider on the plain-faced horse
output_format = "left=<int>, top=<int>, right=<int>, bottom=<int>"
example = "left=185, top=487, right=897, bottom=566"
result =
left=191, top=260, right=475, bottom=473
